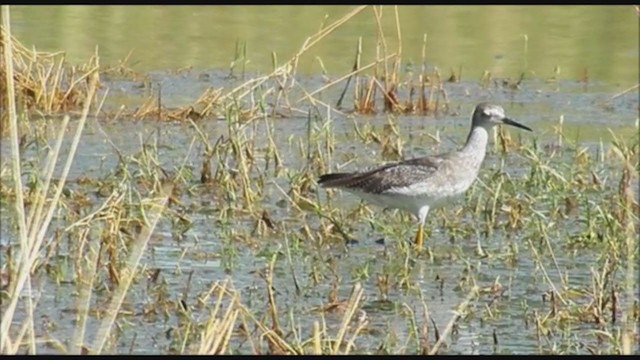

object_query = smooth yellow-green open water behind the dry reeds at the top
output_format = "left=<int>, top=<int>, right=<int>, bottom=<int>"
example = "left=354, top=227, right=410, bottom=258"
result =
left=11, top=5, right=639, bottom=88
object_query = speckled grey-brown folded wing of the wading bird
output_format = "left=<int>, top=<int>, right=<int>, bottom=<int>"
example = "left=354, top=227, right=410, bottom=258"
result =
left=318, top=156, right=443, bottom=194
